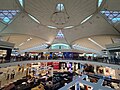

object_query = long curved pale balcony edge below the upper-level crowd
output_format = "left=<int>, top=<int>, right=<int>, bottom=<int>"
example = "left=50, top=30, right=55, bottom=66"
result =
left=0, top=60, right=120, bottom=69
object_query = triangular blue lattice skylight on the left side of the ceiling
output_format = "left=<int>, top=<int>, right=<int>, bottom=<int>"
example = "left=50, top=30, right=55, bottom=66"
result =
left=0, top=10, right=19, bottom=24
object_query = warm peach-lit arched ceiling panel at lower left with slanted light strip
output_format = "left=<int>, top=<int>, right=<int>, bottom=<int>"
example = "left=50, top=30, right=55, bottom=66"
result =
left=2, top=34, right=46, bottom=50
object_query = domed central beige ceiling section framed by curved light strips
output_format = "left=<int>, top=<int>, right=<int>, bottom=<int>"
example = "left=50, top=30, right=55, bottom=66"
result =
left=25, top=0, right=97, bottom=28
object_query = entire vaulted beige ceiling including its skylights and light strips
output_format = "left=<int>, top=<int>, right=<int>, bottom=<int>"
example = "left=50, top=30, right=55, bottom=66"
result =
left=0, top=0, right=120, bottom=51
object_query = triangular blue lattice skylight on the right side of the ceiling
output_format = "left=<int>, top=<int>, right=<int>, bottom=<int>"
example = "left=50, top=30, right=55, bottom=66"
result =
left=101, top=10, right=120, bottom=23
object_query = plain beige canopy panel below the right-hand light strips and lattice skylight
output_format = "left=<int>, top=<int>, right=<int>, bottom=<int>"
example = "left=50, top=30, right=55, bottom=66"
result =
left=63, top=14, right=119, bottom=42
